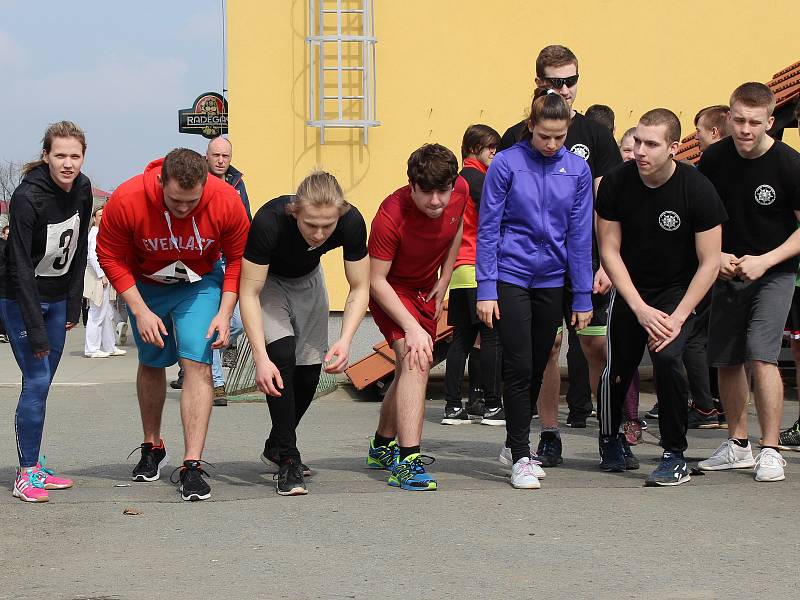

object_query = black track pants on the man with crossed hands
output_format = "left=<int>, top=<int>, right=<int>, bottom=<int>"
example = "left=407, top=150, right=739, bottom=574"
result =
left=597, top=288, right=694, bottom=452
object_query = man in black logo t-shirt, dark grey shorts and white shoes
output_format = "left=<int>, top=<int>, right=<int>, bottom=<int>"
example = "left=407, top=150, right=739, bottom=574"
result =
left=698, top=83, right=800, bottom=481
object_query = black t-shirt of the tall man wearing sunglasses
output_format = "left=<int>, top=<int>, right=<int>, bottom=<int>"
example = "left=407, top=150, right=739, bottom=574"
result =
left=497, top=112, right=622, bottom=177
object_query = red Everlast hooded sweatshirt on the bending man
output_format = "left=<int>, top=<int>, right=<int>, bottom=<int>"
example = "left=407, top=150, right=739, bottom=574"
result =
left=97, top=158, right=250, bottom=293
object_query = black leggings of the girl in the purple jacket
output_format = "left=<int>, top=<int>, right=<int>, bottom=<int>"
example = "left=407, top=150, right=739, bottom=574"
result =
left=495, top=282, right=563, bottom=462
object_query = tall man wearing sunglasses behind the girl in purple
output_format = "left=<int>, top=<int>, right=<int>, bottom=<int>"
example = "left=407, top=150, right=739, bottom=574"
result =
left=497, top=45, right=622, bottom=467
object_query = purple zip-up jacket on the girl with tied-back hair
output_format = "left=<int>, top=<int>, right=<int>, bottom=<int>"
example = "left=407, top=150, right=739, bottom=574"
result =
left=475, top=141, right=594, bottom=312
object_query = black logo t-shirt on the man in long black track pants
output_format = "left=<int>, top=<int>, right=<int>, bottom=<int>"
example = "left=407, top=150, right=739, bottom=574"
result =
left=596, top=160, right=727, bottom=293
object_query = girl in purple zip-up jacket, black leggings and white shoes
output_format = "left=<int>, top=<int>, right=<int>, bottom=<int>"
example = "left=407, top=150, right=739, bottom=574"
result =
left=476, top=90, right=593, bottom=489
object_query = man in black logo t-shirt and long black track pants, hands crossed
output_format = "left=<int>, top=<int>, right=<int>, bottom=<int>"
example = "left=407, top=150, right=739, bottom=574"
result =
left=597, top=108, right=727, bottom=485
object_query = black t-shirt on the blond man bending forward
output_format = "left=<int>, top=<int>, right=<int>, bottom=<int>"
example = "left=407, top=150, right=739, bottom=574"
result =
left=244, top=196, right=367, bottom=277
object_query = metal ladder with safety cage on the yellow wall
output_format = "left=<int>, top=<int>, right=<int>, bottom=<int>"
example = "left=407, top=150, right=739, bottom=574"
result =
left=306, top=0, right=380, bottom=145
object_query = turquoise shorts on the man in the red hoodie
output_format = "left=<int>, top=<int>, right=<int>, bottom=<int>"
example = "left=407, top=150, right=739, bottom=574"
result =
left=130, top=262, right=224, bottom=367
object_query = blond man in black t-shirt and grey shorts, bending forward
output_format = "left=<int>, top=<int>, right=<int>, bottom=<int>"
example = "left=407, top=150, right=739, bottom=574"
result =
left=239, top=171, right=369, bottom=496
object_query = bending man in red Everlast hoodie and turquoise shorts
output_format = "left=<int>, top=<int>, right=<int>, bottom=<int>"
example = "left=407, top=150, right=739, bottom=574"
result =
left=97, top=148, right=249, bottom=500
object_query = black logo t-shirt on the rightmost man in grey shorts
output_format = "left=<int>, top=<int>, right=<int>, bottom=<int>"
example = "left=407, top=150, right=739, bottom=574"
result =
left=698, top=137, right=800, bottom=273
